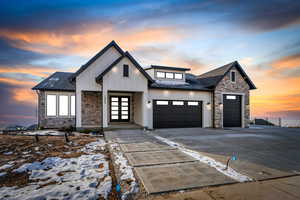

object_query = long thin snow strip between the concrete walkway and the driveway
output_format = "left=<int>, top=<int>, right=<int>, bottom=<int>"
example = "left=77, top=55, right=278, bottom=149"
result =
left=154, top=136, right=252, bottom=182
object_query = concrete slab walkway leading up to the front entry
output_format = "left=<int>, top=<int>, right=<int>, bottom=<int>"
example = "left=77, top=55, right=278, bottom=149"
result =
left=105, top=130, right=236, bottom=194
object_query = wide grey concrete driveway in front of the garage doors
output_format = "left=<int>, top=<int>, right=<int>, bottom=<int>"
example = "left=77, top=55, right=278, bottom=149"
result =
left=153, top=127, right=300, bottom=180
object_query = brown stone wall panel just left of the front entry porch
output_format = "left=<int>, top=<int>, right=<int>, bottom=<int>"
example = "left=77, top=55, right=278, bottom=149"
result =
left=81, top=91, right=102, bottom=127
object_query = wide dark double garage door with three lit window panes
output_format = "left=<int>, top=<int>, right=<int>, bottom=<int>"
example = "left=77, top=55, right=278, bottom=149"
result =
left=153, top=100, right=202, bottom=128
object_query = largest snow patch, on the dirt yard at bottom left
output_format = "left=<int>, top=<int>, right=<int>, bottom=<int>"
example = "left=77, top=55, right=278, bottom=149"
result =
left=0, top=139, right=112, bottom=200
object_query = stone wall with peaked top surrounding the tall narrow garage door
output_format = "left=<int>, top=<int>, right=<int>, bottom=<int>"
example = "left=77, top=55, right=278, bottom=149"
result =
left=214, top=67, right=250, bottom=128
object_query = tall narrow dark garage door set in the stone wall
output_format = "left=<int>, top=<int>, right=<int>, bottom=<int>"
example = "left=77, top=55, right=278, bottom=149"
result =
left=223, top=94, right=242, bottom=127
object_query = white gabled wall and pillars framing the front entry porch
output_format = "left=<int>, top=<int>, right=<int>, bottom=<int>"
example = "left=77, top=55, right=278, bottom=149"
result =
left=102, top=57, right=148, bottom=128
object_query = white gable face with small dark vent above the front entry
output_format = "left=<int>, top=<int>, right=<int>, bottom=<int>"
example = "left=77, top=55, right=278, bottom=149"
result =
left=102, top=56, right=148, bottom=91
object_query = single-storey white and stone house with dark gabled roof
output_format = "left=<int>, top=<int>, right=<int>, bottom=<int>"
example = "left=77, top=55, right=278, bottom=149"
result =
left=32, top=41, right=256, bottom=129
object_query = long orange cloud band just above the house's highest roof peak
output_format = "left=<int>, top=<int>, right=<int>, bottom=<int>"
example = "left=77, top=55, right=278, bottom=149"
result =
left=0, top=24, right=186, bottom=56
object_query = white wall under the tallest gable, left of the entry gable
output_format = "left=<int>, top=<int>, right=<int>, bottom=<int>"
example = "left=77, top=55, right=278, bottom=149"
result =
left=76, top=47, right=121, bottom=127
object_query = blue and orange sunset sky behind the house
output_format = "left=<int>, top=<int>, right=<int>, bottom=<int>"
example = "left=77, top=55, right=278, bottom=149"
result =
left=0, top=0, right=300, bottom=125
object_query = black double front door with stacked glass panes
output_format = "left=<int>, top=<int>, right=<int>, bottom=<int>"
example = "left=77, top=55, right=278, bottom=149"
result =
left=110, top=96, right=130, bottom=122
